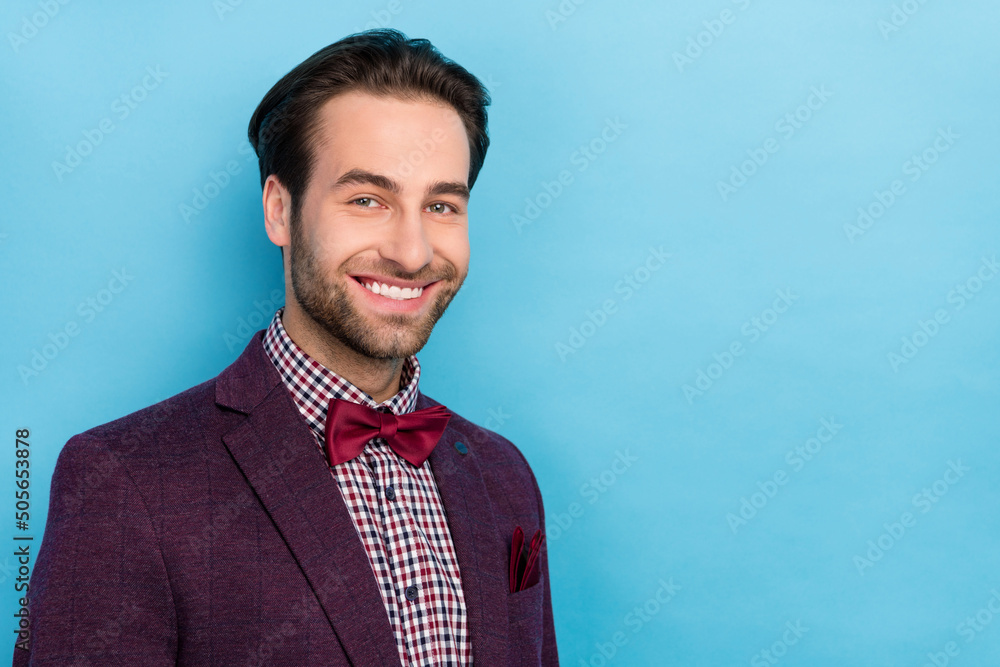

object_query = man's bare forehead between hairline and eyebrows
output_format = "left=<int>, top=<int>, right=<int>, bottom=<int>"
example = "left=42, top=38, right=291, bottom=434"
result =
left=314, top=91, right=470, bottom=183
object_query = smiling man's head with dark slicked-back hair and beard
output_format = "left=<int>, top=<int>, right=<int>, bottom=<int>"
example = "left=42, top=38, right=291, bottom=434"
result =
left=249, top=30, right=489, bottom=366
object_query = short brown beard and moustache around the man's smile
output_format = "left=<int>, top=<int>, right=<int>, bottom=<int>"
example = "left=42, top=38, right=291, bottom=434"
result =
left=289, top=213, right=465, bottom=360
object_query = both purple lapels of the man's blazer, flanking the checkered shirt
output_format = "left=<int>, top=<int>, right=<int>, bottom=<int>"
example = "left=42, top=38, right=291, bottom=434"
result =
left=215, top=330, right=509, bottom=665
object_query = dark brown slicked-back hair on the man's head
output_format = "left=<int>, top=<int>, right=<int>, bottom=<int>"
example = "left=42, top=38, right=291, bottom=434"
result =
left=247, top=29, right=490, bottom=219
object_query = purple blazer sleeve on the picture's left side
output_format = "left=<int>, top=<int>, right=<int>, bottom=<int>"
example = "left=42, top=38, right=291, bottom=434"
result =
left=14, top=435, right=177, bottom=667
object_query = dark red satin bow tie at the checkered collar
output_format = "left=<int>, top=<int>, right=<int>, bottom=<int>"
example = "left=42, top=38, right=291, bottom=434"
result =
left=325, top=398, right=451, bottom=466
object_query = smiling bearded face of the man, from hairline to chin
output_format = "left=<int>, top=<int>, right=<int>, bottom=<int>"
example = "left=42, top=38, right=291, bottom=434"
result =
left=282, top=92, right=469, bottom=359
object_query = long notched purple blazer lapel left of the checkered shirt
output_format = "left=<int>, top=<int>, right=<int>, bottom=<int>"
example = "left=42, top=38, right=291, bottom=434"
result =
left=216, top=331, right=398, bottom=665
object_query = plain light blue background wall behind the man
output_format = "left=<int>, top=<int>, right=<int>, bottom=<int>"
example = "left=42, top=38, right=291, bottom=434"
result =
left=0, top=0, right=1000, bottom=666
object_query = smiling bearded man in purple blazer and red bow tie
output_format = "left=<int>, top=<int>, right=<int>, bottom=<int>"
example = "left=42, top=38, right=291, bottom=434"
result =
left=14, top=30, right=558, bottom=666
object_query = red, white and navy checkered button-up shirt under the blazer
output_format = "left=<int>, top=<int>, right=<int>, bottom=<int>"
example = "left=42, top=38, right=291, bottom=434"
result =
left=264, top=308, right=472, bottom=667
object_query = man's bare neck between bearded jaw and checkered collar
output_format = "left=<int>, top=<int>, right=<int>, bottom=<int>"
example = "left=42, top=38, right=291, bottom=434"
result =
left=281, top=300, right=405, bottom=403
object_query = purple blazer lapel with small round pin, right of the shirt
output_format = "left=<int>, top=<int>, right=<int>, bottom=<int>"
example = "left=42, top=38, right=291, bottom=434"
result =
left=416, top=393, right=509, bottom=665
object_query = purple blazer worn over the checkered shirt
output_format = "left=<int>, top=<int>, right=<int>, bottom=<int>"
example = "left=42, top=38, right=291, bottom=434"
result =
left=13, top=331, right=558, bottom=667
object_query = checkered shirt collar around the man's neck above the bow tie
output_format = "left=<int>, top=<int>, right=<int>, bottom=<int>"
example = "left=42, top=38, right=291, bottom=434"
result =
left=264, top=307, right=420, bottom=441
